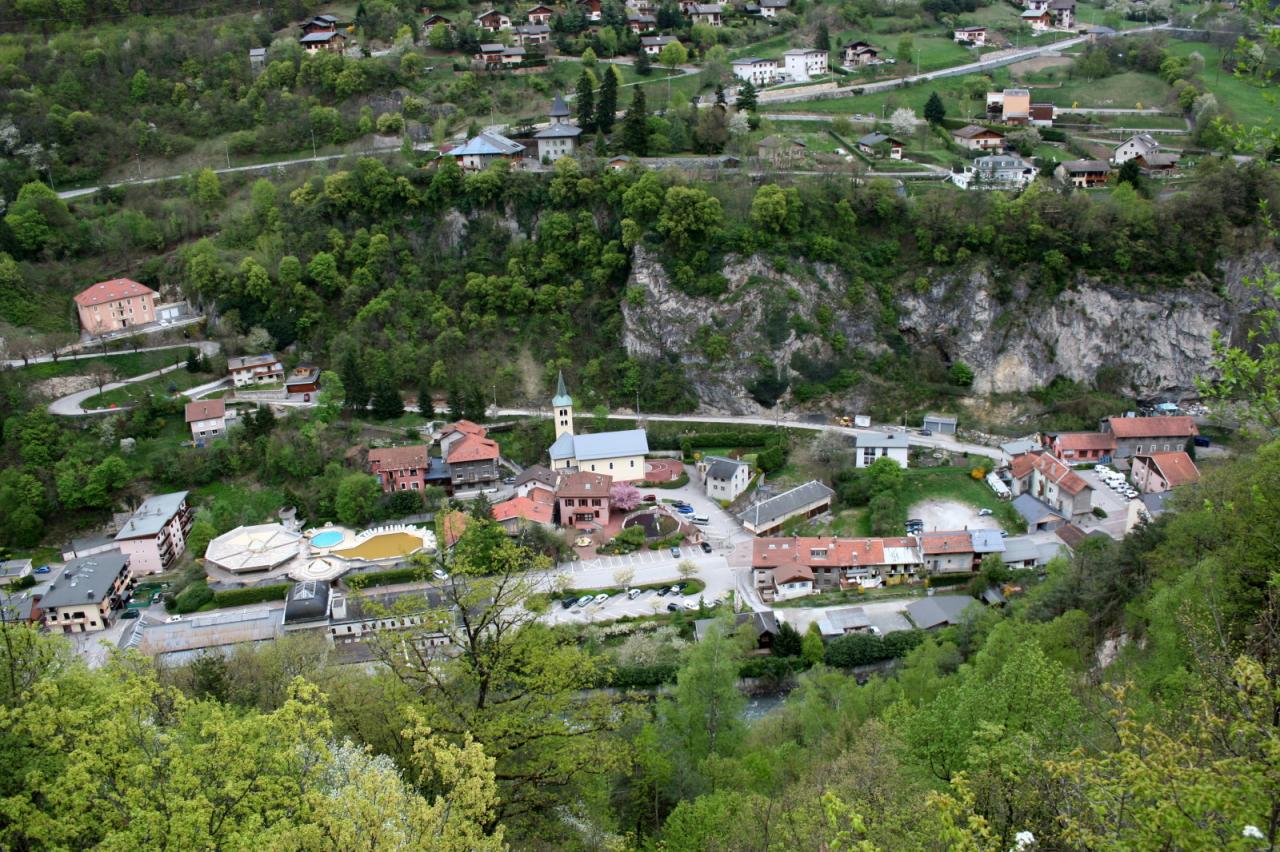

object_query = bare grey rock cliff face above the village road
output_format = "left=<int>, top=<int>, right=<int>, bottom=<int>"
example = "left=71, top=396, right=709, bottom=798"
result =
left=623, top=247, right=1276, bottom=413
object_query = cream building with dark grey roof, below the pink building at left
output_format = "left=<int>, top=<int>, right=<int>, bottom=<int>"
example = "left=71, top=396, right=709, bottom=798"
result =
left=40, top=551, right=137, bottom=633
